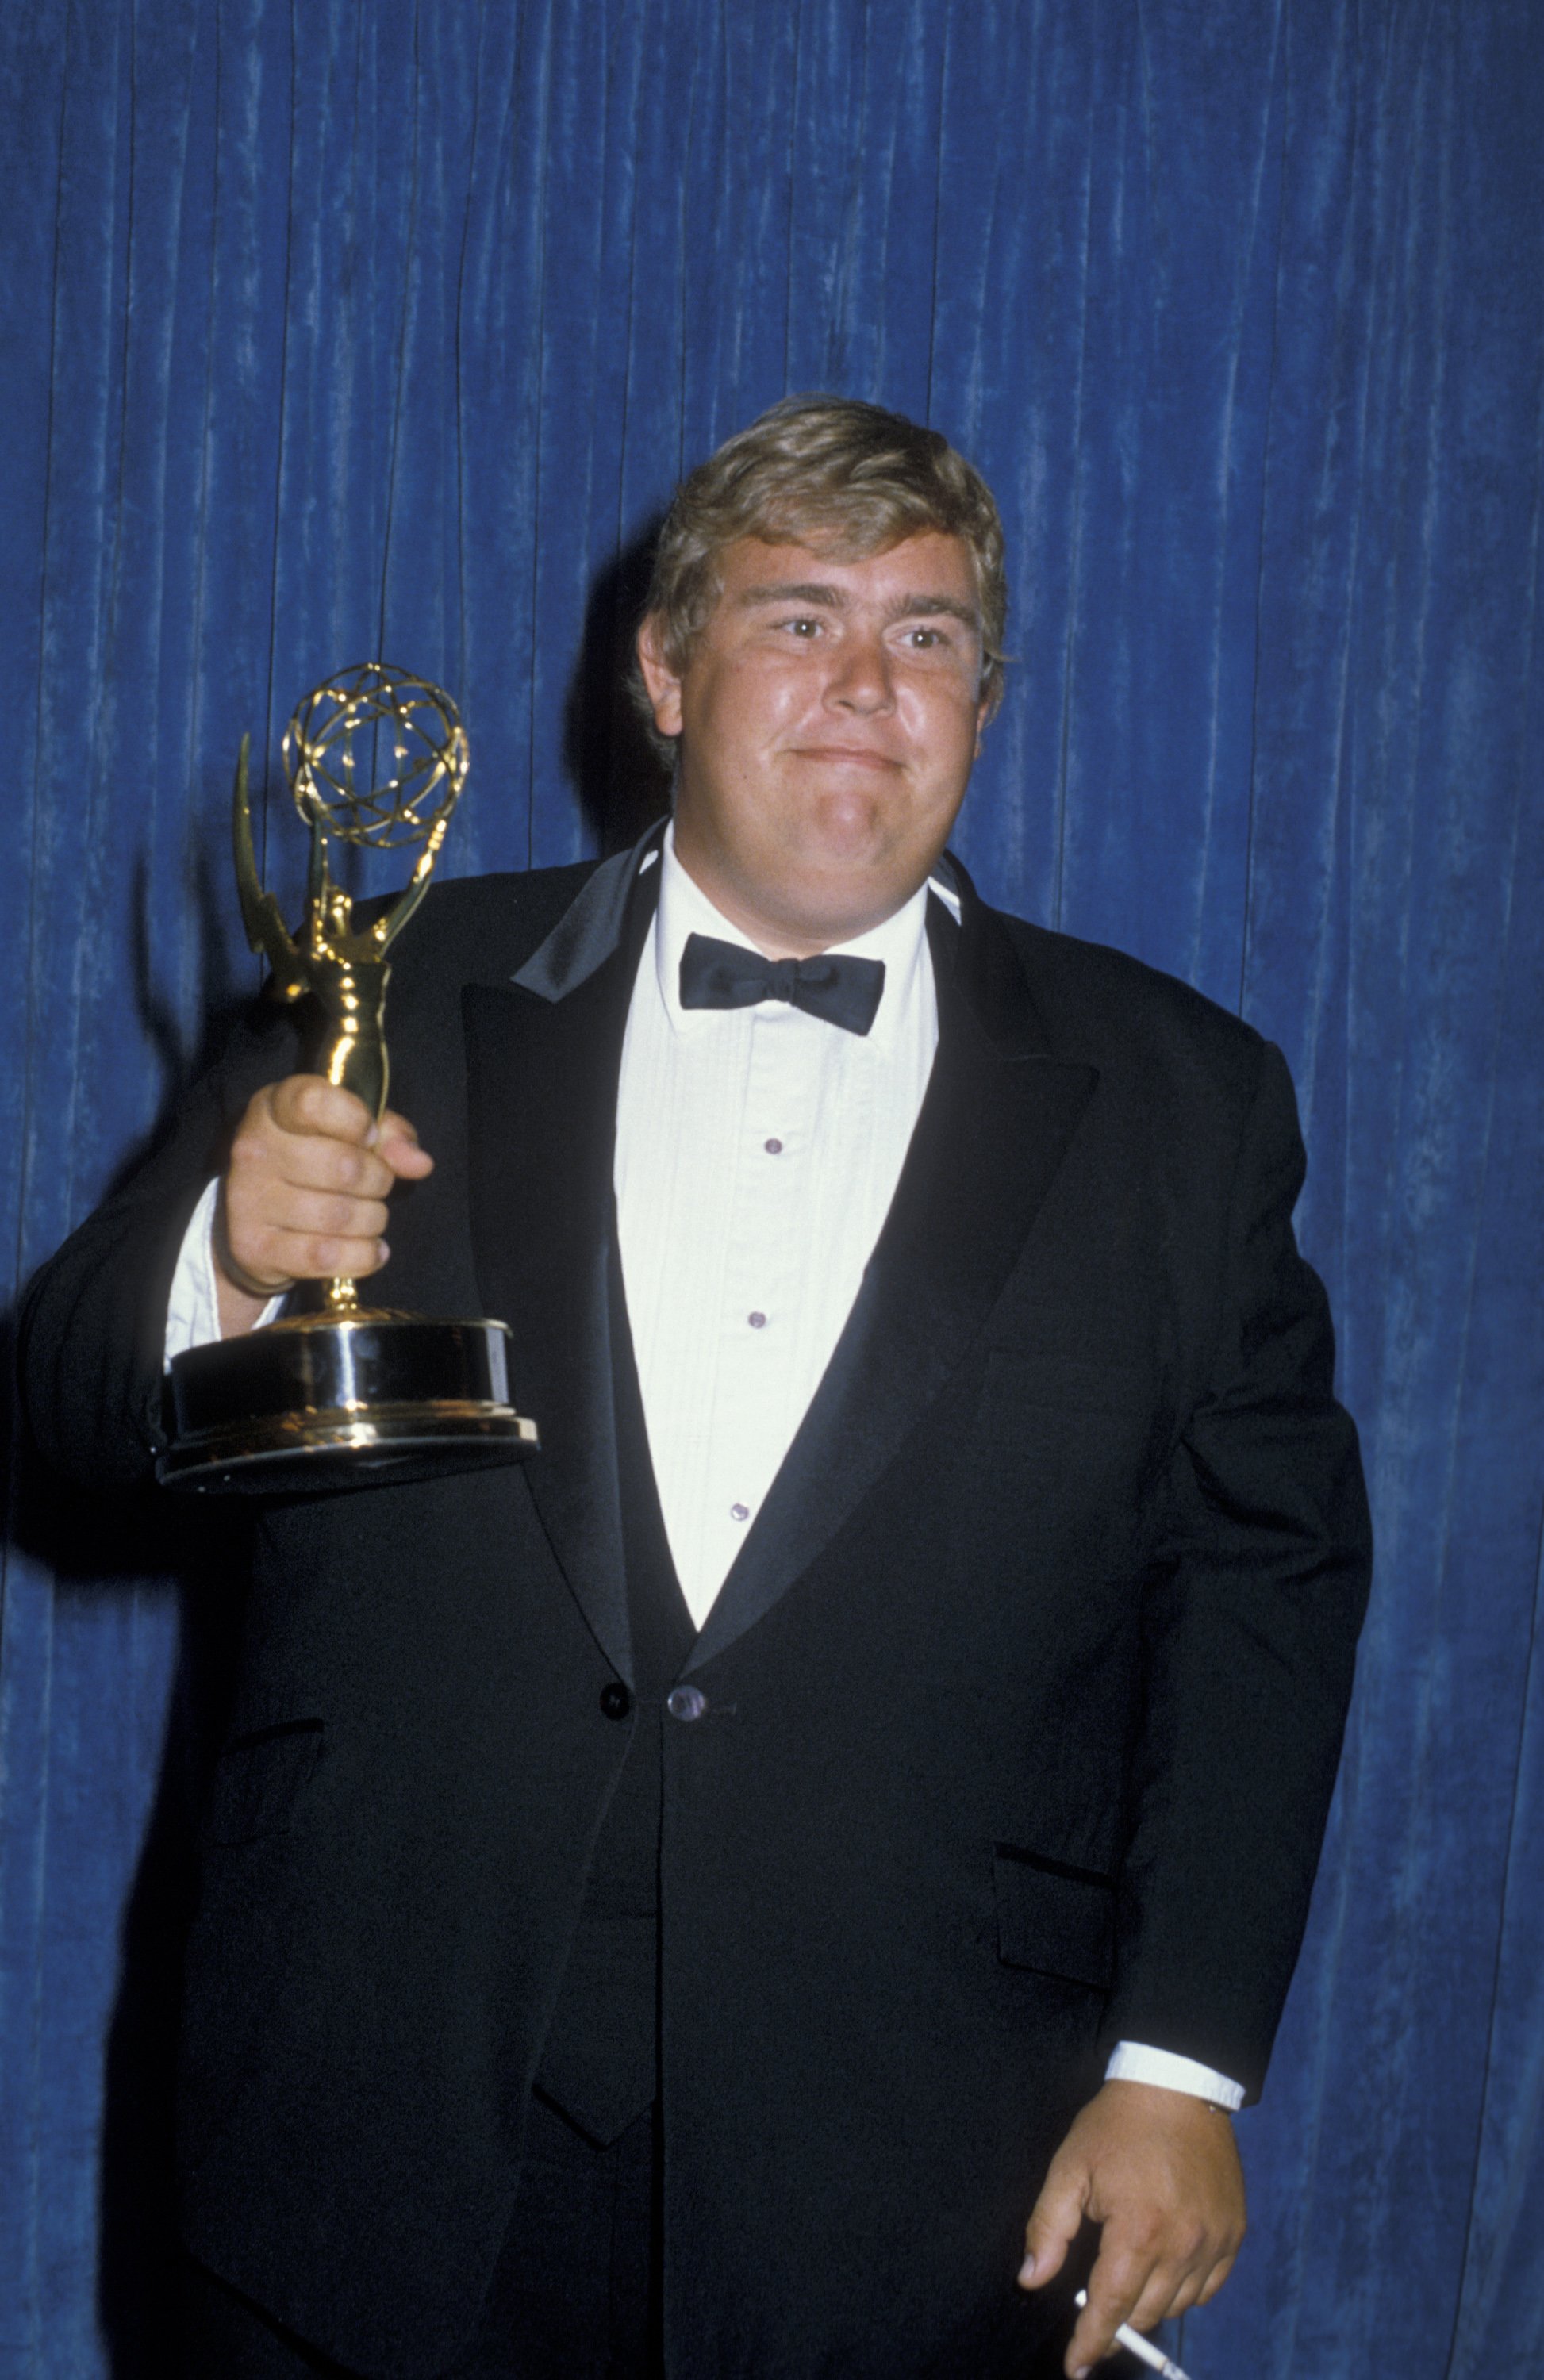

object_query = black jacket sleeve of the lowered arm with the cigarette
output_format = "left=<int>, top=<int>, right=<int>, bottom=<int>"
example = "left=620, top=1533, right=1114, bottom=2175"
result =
left=1108, top=1045, right=1373, bottom=2099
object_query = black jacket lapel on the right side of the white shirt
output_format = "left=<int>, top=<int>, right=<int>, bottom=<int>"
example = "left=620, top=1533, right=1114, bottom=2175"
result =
left=688, top=883, right=1097, bottom=1668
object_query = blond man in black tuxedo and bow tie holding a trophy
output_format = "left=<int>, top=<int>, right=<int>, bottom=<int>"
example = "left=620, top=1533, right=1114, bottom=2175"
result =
left=26, top=397, right=1368, bottom=2380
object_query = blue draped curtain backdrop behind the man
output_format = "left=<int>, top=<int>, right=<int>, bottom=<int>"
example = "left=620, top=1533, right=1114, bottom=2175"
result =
left=0, top=0, right=1544, bottom=2380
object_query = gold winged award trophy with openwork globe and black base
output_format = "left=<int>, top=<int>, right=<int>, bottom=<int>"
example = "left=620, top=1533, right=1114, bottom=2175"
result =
left=157, top=662, right=538, bottom=1495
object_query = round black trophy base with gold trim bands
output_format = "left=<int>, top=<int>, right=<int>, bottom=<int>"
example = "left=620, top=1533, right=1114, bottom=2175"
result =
left=155, top=1309, right=540, bottom=1495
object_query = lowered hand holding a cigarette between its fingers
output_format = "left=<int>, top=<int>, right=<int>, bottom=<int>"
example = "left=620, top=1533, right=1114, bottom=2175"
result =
left=1018, top=2082, right=1244, bottom=2380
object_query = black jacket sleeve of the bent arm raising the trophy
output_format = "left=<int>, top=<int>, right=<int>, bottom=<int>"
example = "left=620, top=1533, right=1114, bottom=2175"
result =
left=19, top=1002, right=300, bottom=1488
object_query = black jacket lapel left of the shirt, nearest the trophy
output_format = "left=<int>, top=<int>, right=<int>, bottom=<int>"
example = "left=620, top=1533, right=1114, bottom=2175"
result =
left=462, top=854, right=657, bottom=1683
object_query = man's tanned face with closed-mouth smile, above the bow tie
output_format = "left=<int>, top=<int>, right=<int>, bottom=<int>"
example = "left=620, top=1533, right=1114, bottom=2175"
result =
left=638, top=528, right=985, bottom=957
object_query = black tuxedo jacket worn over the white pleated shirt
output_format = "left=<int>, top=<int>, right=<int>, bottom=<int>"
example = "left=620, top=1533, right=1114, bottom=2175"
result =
left=24, top=838, right=1368, bottom=2380
